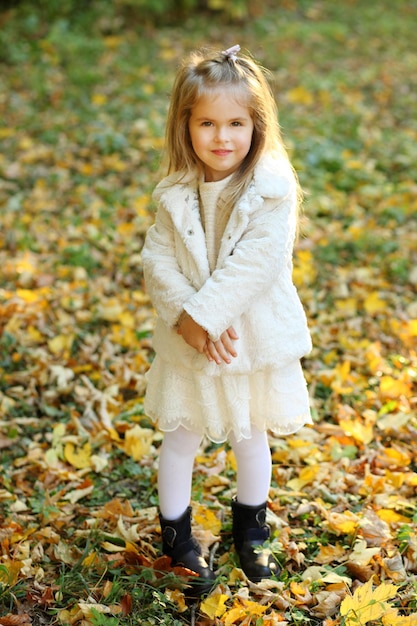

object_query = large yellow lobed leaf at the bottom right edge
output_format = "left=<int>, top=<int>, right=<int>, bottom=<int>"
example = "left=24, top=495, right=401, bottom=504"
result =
left=340, top=578, right=398, bottom=626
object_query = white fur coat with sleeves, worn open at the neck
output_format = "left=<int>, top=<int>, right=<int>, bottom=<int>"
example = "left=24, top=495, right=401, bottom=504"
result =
left=142, top=157, right=311, bottom=374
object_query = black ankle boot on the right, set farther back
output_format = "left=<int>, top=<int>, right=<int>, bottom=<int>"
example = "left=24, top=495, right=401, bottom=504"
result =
left=232, top=500, right=281, bottom=582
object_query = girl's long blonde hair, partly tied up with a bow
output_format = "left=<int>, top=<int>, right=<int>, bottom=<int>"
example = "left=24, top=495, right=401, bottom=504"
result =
left=165, top=50, right=301, bottom=214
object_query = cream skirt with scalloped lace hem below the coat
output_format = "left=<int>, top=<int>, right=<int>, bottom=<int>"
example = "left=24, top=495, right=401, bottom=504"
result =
left=144, top=355, right=312, bottom=443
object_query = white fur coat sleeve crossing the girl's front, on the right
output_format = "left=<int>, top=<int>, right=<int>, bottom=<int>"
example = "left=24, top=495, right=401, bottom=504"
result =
left=184, top=189, right=296, bottom=341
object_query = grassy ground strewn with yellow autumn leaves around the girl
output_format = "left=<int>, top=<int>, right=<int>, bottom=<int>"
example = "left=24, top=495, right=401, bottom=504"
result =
left=0, top=0, right=417, bottom=626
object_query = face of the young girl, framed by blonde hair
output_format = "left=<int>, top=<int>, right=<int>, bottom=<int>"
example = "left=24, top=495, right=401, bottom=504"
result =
left=188, top=90, right=253, bottom=182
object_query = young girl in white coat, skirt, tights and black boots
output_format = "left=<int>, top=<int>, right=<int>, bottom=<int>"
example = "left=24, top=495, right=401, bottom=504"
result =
left=142, top=46, right=311, bottom=594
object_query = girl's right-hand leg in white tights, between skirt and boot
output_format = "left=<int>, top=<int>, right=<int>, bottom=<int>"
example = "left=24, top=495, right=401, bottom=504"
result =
left=229, top=426, right=272, bottom=506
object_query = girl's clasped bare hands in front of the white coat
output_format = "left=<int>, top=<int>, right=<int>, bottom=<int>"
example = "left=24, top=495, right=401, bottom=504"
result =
left=177, top=311, right=239, bottom=365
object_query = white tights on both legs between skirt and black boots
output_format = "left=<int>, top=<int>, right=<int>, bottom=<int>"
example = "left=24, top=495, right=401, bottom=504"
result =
left=158, top=426, right=271, bottom=520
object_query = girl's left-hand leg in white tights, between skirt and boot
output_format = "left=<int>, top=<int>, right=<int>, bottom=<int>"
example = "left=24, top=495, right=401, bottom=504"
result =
left=158, top=426, right=201, bottom=520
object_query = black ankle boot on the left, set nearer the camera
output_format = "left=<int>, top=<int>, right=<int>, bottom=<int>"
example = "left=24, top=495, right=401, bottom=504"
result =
left=159, top=506, right=216, bottom=597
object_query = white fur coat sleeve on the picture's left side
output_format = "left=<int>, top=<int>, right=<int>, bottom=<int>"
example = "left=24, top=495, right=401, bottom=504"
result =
left=142, top=203, right=196, bottom=327
